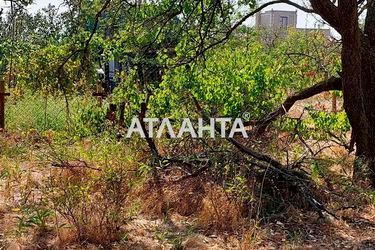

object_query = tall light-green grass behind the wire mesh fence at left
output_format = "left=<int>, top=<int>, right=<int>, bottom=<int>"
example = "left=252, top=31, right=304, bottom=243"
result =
left=5, top=93, right=108, bottom=137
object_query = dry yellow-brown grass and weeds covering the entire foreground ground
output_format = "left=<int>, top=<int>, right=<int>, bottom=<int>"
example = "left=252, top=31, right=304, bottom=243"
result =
left=0, top=128, right=375, bottom=249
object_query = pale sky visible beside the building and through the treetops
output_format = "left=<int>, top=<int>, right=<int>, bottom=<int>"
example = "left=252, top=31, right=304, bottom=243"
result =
left=0, top=0, right=327, bottom=28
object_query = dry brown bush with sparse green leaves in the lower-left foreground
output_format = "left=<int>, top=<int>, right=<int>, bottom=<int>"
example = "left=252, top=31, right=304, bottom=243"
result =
left=49, top=168, right=129, bottom=246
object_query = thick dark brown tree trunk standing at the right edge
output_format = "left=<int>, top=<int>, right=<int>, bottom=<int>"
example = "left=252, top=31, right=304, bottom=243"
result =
left=342, top=2, right=375, bottom=186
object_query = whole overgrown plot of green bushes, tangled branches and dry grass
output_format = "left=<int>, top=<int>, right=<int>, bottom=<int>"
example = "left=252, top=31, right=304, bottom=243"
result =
left=0, top=0, right=375, bottom=249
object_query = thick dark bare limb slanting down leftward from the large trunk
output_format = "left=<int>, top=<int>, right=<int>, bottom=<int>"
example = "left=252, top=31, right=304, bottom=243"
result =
left=244, top=77, right=342, bottom=134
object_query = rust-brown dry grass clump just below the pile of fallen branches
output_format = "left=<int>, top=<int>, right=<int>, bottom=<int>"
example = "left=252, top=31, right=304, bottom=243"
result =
left=134, top=169, right=244, bottom=232
